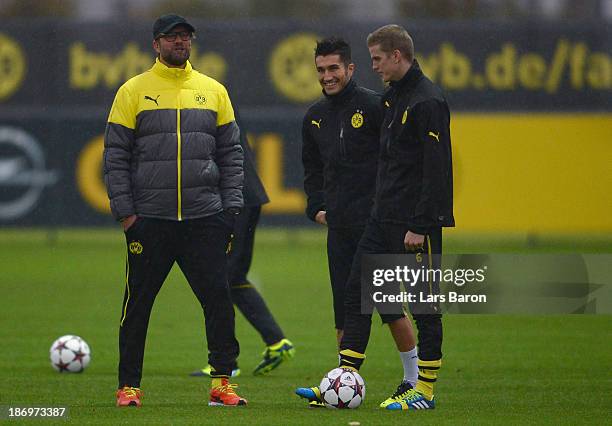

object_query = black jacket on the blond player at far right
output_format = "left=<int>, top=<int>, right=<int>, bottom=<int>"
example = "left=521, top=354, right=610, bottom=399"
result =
left=373, top=61, right=455, bottom=234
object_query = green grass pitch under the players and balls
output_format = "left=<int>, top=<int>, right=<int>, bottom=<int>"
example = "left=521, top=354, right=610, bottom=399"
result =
left=0, top=229, right=612, bottom=425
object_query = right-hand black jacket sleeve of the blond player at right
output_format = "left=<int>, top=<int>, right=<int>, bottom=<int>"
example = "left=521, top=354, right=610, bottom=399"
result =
left=410, top=99, right=451, bottom=235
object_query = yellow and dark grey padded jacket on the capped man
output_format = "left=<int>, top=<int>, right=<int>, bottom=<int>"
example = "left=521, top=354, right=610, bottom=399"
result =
left=104, top=59, right=243, bottom=220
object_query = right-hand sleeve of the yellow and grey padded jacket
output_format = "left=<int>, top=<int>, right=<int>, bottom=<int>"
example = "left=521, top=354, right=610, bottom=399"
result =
left=215, top=87, right=244, bottom=210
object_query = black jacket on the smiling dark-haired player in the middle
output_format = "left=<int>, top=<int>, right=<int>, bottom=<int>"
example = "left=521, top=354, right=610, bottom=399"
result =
left=302, top=80, right=382, bottom=227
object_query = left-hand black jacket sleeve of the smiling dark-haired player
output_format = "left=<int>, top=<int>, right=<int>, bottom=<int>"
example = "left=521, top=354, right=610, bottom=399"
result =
left=302, top=115, right=325, bottom=221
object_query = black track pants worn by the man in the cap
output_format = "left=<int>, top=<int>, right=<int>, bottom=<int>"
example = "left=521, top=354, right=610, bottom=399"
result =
left=119, top=212, right=239, bottom=387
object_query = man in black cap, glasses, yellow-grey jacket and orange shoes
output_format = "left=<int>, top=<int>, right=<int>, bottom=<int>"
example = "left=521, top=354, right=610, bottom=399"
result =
left=104, top=11, right=247, bottom=407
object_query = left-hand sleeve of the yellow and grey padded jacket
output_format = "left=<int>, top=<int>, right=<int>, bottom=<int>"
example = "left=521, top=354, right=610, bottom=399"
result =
left=103, top=85, right=137, bottom=220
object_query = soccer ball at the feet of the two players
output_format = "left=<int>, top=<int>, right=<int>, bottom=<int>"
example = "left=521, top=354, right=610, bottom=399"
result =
left=319, top=368, right=365, bottom=408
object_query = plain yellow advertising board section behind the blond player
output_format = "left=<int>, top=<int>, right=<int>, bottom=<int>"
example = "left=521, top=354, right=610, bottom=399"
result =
left=451, top=113, right=612, bottom=235
